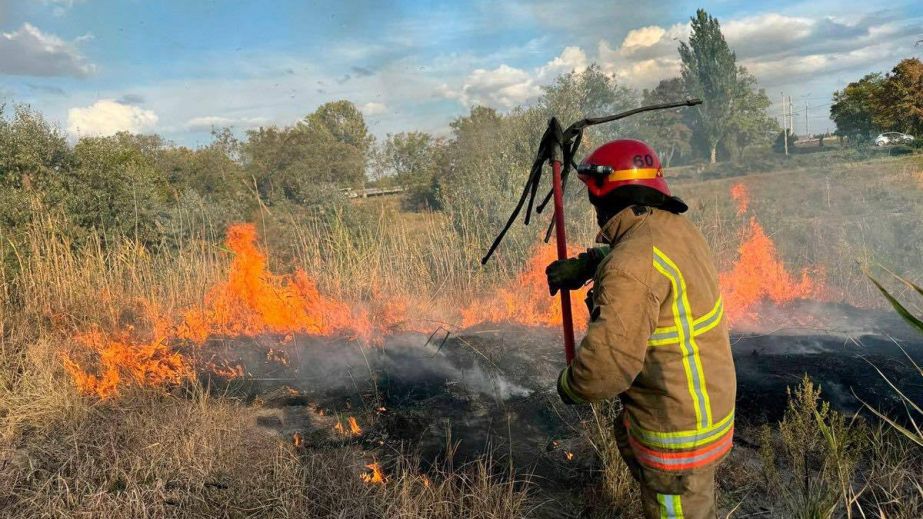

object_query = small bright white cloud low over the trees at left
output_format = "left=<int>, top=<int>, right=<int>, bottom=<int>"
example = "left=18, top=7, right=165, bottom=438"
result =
left=67, top=99, right=158, bottom=137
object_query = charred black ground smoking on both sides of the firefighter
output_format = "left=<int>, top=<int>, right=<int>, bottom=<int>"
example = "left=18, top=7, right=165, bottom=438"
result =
left=202, top=304, right=923, bottom=486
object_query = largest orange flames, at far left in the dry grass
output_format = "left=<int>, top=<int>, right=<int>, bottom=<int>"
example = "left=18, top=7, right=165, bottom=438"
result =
left=64, top=224, right=418, bottom=398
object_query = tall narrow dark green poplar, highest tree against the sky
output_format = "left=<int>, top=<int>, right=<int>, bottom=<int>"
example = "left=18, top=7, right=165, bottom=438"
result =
left=679, top=9, right=739, bottom=164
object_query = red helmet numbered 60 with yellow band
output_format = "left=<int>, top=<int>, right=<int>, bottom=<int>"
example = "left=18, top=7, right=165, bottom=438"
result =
left=577, top=139, right=673, bottom=198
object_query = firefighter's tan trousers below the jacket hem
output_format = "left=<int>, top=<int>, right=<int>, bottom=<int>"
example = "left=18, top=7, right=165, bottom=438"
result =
left=615, top=417, right=717, bottom=519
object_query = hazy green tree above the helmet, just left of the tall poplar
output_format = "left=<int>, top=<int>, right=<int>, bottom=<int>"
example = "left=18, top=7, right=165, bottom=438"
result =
left=639, top=78, right=692, bottom=166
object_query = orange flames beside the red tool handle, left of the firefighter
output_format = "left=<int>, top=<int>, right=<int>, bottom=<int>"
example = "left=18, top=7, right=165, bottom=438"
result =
left=461, top=244, right=589, bottom=330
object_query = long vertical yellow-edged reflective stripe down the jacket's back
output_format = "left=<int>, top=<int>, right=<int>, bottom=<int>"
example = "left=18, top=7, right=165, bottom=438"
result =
left=654, top=247, right=712, bottom=427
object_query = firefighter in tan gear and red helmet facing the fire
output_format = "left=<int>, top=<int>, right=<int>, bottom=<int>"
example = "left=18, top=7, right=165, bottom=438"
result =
left=546, top=139, right=737, bottom=518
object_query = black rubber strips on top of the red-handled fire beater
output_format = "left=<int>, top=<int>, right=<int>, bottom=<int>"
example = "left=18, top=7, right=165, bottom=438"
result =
left=481, top=99, right=702, bottom=265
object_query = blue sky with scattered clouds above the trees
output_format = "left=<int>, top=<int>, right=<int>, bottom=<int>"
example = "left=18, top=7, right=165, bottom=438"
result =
left=0, top=0, right=923, bottom=145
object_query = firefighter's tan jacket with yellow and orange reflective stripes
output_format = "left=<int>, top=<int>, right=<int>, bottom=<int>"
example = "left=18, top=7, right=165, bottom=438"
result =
left=562, top=206, right=737, bottom=472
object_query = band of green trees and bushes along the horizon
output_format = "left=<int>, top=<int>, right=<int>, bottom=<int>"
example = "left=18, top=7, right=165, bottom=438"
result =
left=0, top=10, right=919, bottom=258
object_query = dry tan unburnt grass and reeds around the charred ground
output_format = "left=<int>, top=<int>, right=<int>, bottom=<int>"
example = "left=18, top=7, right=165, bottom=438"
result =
left=0, top=153, right=923, bottom=517
